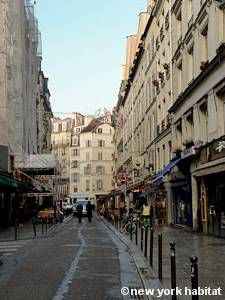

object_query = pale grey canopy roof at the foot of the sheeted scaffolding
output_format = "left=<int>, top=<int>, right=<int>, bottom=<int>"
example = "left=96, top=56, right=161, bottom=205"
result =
left=18, top=154, right=59, bottom=169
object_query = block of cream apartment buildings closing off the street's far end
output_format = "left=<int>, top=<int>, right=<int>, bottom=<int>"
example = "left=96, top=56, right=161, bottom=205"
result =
left=52, top=113, right=114, bottom=203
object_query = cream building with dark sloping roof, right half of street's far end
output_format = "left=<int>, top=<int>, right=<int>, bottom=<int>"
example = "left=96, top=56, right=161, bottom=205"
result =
left=78, top=114, right=114, bottom=200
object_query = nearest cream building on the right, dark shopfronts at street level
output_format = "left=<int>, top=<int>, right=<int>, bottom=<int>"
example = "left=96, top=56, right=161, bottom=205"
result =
left=170, top=1, right=225, bottom=236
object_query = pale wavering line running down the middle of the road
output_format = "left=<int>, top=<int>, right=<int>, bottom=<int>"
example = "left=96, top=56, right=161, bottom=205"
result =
left=52, top=224, right=86, bottom=300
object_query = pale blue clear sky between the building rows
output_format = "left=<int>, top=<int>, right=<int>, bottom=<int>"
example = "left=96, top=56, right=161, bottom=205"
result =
left=35, top=0, right=147, bottom=114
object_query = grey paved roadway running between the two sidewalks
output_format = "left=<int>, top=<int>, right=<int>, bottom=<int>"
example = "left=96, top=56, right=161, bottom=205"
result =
left=0, top=218, right=141, bottom=300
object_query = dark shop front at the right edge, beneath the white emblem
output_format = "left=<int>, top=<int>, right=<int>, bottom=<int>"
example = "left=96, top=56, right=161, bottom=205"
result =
left=193, top=137, right=225, bottom=237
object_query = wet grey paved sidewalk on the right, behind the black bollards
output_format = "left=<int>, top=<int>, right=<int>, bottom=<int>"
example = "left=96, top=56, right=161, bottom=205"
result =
left=118, top=221, right=225, bottom=300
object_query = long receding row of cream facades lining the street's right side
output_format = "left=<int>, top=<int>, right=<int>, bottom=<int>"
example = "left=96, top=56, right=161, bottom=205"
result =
left=114, top=0, right=225, bottom=235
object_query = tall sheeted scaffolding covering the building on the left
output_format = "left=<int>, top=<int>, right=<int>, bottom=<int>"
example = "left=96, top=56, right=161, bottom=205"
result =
left=0, top=0, right=41, bottom=168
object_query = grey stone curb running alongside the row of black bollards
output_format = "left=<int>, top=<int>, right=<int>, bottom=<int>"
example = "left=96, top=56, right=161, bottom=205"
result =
left=101, top=218, right=169, bottom=300
